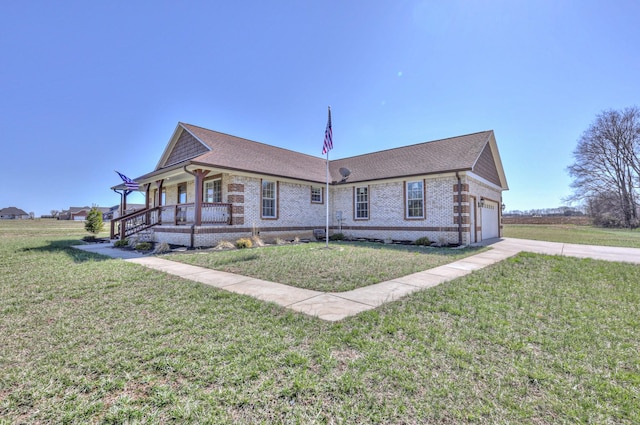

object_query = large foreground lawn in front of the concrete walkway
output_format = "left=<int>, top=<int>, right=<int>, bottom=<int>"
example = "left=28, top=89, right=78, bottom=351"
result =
left=0, top=222, right=640, bottom=424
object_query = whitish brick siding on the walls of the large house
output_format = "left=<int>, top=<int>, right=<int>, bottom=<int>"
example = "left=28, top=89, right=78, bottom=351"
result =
left=148, top=173, right=501, bottom=246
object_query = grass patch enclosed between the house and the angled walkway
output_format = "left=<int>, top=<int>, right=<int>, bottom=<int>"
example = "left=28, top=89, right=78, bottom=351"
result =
left=163, top=242, right=480, bottom=292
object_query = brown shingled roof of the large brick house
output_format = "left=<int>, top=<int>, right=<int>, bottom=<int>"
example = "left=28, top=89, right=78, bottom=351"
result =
left=130, top=123, right=507, bottom=189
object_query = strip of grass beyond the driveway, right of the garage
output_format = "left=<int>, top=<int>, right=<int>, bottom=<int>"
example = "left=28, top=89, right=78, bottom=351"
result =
left=504, top=224, right=640, bottom=248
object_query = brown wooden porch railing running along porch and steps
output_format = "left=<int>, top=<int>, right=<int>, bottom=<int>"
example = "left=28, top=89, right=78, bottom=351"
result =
left=111, top=202, right=232, bottom=239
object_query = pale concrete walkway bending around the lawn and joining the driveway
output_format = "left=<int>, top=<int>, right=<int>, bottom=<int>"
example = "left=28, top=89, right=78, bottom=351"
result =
left=75, top=238, right=640, bottom=321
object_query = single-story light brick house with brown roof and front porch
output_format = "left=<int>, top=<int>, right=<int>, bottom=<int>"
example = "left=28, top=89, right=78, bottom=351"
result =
left=112, top=123, right=508, bottom=247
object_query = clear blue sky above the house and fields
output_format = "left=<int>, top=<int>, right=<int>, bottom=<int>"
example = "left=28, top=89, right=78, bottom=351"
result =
left=0, top=0, right=640, bottom=216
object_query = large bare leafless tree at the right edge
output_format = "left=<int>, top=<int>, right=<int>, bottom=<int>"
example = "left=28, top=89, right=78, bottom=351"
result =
left=568, top=107, right=640, bottom=228
